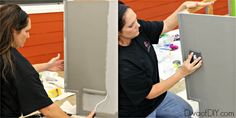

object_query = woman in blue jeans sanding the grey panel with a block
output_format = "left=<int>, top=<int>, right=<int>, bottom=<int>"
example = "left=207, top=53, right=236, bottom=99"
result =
left=118, top=2, right=213, bottom=118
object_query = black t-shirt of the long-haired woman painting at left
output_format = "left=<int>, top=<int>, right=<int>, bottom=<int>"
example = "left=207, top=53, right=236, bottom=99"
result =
left=0, top=48, right=53, bottom=117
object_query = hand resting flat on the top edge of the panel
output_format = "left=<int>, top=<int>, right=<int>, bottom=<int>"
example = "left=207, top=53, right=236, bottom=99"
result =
left=182, top=0, right=216, bottom=13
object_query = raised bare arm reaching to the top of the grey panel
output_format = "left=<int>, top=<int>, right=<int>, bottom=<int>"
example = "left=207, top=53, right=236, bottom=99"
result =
left=162, top=1, right=214, bottom=33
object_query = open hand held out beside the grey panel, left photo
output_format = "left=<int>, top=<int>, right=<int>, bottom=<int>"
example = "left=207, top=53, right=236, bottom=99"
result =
left=47, top=54, right=64, bottom=72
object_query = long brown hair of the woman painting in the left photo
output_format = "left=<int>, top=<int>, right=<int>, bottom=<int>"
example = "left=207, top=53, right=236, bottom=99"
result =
left=0, top=4, right=29, bottom=79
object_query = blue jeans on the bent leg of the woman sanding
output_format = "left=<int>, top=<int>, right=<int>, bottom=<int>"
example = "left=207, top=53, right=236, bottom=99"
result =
left=147, top=92, right=193, bottom=118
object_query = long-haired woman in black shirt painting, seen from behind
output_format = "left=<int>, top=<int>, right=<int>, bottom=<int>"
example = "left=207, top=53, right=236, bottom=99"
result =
left=0, top=4, right=68, bottom=118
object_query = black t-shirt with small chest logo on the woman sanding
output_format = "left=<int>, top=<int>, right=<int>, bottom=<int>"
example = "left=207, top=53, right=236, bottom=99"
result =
left=119, top=20, right=166, bottom=117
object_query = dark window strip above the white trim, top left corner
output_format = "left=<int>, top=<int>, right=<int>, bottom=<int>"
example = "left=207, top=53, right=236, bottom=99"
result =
left=0, top=0, right=63, bottom=4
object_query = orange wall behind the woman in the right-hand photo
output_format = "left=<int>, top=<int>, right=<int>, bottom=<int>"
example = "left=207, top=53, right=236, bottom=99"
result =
left=122, top=0, right=228, bottom=20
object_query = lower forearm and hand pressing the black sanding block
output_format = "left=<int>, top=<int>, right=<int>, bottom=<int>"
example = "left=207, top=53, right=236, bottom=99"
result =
left=146, top=53, right=202, bottom=99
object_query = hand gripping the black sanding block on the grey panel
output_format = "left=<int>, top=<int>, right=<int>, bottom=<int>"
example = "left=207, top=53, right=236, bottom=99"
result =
left=177, top=53, right=202, bottom=77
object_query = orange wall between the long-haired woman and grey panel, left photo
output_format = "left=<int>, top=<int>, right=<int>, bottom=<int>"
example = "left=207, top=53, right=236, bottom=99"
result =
left=19, top=12, right=64, bottom=64
